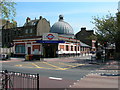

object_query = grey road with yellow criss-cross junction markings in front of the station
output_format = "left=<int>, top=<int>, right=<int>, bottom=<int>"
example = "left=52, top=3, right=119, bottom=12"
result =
left=2, top=56, right=118, bottom=88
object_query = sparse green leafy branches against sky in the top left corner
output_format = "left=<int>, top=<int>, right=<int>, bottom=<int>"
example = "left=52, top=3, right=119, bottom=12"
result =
left=0, top=0, right=16, bottom=21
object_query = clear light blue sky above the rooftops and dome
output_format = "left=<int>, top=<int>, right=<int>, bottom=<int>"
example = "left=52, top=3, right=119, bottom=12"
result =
left=15, top=0, right=118, bottom=34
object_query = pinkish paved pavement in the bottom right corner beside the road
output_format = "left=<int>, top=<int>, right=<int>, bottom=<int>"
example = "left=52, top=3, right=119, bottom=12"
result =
left=70, top=61, right=120, bottom=90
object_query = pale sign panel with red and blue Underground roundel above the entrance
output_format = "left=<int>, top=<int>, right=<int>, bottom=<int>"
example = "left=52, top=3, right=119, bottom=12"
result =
left=42, top=33, right=58, bottom=40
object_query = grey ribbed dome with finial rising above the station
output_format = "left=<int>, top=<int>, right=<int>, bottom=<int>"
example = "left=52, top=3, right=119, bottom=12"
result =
left=50, top=15, right=74, bottom=35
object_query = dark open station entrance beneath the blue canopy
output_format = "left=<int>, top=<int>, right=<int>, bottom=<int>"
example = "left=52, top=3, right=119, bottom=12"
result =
left=43, top=43, right=58, bottom=58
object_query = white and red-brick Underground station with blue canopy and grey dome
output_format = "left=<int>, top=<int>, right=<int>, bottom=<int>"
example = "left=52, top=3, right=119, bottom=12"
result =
left=14, top=15, right=84, bottom=58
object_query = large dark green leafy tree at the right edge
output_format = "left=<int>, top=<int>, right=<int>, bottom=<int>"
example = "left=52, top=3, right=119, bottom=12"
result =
left=92, top=12, right=120, bottom=59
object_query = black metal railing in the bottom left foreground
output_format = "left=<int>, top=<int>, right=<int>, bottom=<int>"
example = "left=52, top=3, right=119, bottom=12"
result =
left=0, top=70, right=39, bottom=90
